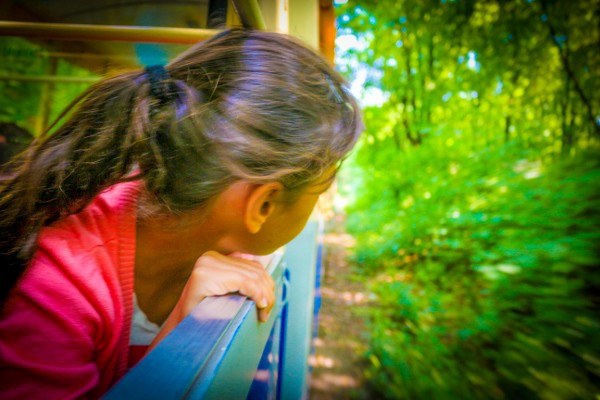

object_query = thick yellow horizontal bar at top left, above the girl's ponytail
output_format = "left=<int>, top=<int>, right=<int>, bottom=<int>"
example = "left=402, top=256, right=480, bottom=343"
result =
left=0, top=21, right=221, bottom=44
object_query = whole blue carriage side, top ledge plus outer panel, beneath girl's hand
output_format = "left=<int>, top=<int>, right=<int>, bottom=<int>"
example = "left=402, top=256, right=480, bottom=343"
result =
left=105, top=222, right=319, bottom=400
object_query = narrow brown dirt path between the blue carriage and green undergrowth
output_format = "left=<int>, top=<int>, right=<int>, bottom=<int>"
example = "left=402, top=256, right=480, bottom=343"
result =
left=310, top=223, right=368, bottom=400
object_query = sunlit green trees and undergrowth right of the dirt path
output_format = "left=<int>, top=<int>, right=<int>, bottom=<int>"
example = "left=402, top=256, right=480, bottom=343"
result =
left=336, top=0, right=600, bottom=399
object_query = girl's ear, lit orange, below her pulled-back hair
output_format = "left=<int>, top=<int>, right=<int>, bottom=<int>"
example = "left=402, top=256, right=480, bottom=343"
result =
left=244, top=182, right=283, bottom=233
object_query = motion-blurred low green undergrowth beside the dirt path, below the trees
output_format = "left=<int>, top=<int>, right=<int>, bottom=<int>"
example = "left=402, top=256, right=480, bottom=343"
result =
left=349, top=140, right=600, bottom=399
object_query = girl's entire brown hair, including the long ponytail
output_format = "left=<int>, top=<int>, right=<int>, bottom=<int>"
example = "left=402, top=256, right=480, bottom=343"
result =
left=0, top=30, right=362, bottom=301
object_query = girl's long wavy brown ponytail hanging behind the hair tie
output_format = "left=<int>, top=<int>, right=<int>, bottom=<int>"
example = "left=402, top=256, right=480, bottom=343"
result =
left=0, top=72, right=176, bottom=304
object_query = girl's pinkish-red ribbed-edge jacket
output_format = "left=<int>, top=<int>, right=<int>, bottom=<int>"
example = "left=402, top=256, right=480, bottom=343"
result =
left=0, top=182, right=139, bottom=399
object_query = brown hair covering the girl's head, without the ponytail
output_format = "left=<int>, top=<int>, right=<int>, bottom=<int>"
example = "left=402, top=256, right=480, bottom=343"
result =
left=145, top=31, right=360, bottom=211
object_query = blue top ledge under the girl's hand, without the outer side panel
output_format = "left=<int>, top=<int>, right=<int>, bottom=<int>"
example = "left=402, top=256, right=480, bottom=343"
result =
left=103, top=252, right=285, bottom=400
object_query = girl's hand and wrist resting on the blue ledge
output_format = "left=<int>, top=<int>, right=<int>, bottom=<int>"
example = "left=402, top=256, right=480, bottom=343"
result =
left=150, top=251, right=275, bottom=349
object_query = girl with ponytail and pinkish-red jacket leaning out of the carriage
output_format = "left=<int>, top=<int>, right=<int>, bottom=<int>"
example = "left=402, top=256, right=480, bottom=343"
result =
left=0, top=30, right=361, bottom=399
